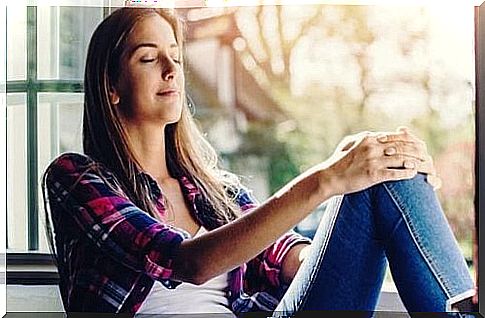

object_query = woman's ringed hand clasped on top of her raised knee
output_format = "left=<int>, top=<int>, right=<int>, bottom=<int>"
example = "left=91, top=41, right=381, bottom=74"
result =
left=324, top=128, right=435, bottom=194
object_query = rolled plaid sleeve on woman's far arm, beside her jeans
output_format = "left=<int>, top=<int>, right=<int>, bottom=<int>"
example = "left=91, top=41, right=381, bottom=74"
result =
left=237, top=189, right=311, bottom=293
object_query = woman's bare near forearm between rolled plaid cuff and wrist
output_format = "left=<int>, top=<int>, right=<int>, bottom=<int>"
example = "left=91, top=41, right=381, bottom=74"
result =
left=172, top=170, right=333, bottom=284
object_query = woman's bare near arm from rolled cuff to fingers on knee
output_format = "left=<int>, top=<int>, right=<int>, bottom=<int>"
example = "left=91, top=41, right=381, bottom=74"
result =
left=172, top=132, right=432, bottom=284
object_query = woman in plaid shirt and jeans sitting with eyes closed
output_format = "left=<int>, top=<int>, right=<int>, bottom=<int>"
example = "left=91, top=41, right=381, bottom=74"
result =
left=43, top=8, right=473, bottom=317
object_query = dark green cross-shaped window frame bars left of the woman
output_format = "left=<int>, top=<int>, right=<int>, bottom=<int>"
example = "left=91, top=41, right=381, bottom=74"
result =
left=5, top=4, right=111, bottom=285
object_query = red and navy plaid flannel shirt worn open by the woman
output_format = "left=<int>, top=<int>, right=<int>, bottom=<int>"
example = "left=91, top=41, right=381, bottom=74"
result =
left=46, top=153, right=310, bottom=314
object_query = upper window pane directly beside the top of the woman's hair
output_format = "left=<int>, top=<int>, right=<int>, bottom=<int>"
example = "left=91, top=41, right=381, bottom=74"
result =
left=37, top=5, right=103, bottom=79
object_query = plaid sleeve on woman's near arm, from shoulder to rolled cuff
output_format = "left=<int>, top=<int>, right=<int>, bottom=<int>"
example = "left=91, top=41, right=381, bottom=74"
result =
left=46, top=153, right=190, bottom=288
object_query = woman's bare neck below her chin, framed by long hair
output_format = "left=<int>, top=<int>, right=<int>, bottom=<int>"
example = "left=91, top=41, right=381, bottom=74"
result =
left=125, top=122, right=171, bottom=183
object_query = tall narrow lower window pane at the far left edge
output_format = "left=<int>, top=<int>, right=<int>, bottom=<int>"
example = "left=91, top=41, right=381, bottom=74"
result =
left=7, top=94, right=27, bottom=251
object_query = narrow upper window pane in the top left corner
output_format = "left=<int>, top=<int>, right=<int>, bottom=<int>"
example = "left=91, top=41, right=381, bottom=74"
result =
left=7, top=5, right=27, bottom=80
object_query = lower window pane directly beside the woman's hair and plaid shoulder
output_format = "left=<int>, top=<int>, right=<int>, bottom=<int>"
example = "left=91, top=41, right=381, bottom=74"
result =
left=37, top=93, right=83, bottom=251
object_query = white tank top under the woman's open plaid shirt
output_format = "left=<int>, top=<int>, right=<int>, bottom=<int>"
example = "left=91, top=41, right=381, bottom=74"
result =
left=135, top=226, right=236, bottom=318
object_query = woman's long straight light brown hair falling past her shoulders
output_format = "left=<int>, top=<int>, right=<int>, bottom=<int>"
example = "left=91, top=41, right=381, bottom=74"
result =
left=43, top=7, right=240, bottom=250
